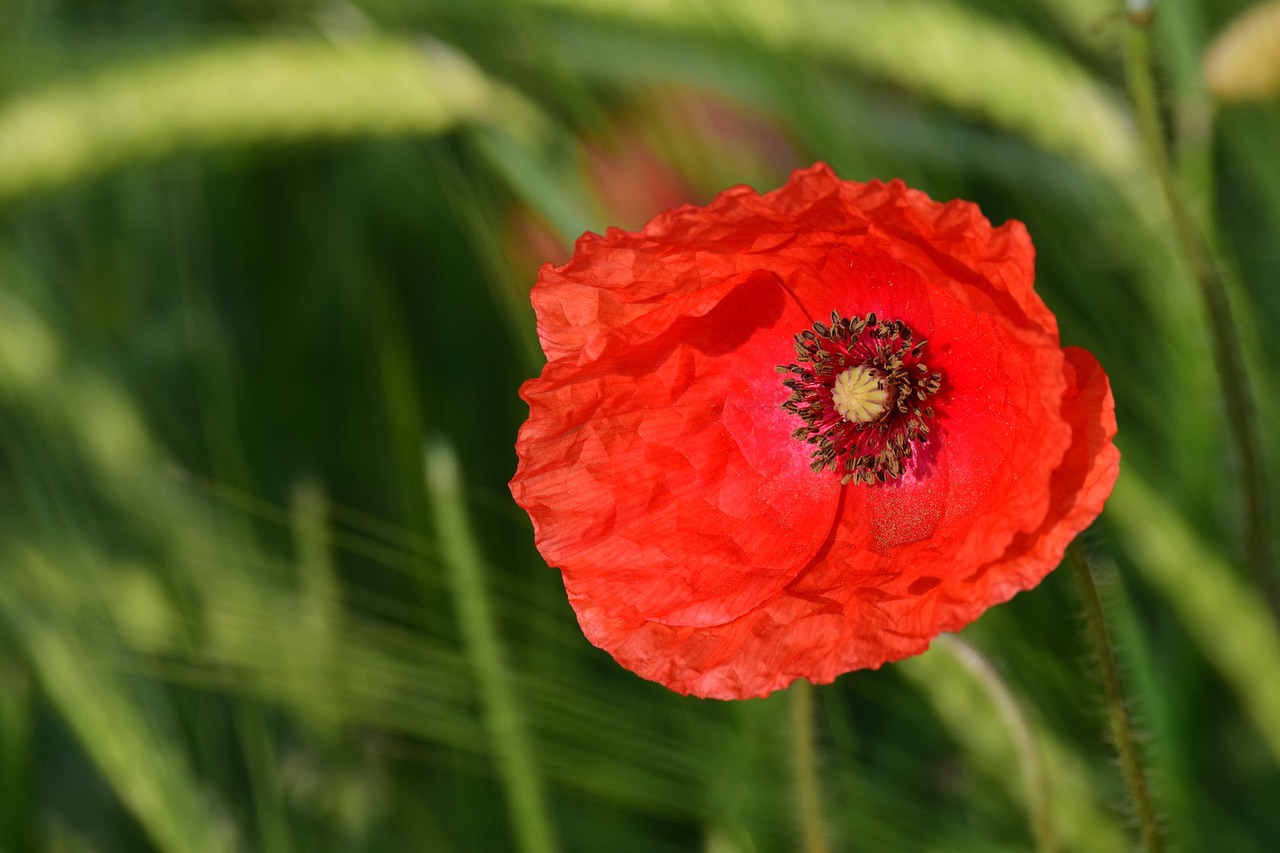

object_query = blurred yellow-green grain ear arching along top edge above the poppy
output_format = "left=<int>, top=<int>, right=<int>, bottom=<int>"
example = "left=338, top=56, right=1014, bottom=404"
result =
left=499, top=0, right=1138, bottom=184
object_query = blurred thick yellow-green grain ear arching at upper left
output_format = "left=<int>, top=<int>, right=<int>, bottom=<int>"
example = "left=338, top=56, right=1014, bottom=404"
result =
left=0, top=38, right=540, bottom=202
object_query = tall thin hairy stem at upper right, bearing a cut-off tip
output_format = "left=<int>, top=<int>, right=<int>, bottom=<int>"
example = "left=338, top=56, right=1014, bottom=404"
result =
left=1125, top=3, right=1280, bottom=626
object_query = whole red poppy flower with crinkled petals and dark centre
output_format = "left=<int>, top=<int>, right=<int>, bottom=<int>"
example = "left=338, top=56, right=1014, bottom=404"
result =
left=511, top=164, right=1119, bottom=698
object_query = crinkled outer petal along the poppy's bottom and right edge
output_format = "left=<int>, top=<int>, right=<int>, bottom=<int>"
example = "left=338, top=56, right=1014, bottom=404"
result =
left=571, top=335, right=1120, bottom=699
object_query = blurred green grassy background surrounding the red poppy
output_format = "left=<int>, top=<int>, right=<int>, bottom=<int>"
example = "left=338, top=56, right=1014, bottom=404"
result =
left=0, top=0, right=1280, bottom=853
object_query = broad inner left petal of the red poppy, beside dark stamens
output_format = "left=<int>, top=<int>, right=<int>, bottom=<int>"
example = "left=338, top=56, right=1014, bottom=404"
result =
left=512, top=273, right=840, bottom=625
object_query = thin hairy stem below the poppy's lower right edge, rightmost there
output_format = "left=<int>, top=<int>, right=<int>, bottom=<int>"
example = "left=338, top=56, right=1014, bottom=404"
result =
left=1066, top=544, right=1165, bottom=853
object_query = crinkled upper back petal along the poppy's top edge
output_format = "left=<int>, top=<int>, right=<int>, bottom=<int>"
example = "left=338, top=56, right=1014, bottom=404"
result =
left=532, top=163, right=1057, bottom=361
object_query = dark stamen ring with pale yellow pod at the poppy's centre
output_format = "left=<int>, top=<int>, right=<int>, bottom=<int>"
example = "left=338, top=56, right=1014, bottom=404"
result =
left=778, top=311, right=942, bottom=483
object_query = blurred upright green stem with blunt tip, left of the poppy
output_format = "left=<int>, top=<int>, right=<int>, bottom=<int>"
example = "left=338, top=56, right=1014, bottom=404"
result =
left=425, top=442, right=556, bottom=853
